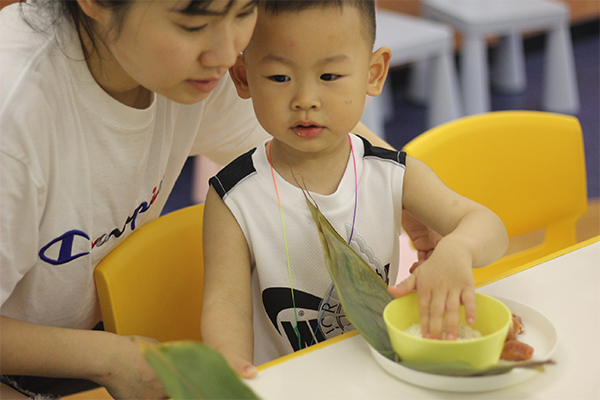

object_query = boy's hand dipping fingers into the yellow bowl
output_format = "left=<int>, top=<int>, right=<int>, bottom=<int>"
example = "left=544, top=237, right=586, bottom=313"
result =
left=388, top=246, right=476, bottom=340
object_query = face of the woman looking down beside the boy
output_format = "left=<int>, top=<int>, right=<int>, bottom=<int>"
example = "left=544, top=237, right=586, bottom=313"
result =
left=90, top=0, right=257, bottom=104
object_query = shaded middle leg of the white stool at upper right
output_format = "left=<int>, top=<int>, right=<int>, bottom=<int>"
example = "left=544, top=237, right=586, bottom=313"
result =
left=491, top=32, right=527, bottom=93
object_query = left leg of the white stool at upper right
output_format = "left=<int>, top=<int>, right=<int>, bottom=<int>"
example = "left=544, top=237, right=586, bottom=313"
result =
left=460, top=35, right=490, bottom=115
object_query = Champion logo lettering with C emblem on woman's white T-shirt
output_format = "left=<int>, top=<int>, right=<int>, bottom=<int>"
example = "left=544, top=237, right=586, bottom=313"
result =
left=38, top=181, right=162, bottom=265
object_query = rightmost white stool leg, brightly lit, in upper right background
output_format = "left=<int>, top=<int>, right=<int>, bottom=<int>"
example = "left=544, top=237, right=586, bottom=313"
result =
left=542, top=23, right=580, bottom=114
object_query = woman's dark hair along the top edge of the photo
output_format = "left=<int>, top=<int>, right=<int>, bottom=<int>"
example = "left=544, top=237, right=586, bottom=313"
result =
left=19, top=0, right=225, bottom=60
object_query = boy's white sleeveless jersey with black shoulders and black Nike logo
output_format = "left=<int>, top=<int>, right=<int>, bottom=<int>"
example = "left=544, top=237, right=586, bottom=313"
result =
left=211, top=135, right=405, bottom=365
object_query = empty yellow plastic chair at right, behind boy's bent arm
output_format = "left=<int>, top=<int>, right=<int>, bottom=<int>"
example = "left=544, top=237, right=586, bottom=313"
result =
left=404, top=111, right=587, bottom=287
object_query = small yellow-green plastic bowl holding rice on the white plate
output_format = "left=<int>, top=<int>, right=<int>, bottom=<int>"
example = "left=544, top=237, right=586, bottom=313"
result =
left=383, top=293, right=512, bottom=369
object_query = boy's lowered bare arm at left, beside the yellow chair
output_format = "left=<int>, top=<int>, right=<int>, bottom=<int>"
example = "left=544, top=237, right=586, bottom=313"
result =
left=202, top=186, right=256, bottom=378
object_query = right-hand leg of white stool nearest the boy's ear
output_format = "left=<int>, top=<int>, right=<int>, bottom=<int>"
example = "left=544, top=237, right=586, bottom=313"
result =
left=427, top=53, right=462, bottom=128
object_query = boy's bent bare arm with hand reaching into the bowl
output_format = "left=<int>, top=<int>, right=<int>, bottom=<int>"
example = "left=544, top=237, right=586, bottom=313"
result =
left=390, top=157, right=508, bottom=338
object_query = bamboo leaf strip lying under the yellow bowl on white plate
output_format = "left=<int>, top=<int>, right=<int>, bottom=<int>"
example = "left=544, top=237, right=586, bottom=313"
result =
left=400, top=360, right=555, bottom=376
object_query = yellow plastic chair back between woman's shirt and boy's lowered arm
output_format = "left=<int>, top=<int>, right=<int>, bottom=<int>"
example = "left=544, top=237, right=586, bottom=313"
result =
left=94, top=204, right=204, bottom=342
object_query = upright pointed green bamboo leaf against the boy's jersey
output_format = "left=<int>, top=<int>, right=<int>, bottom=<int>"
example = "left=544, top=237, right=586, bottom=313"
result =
left=305, top=197, right=397, bottom=360
